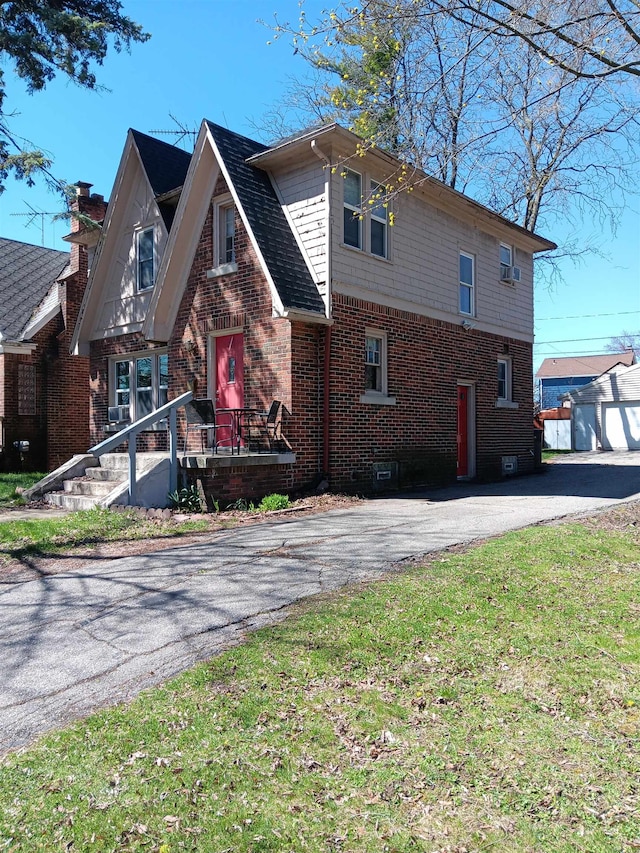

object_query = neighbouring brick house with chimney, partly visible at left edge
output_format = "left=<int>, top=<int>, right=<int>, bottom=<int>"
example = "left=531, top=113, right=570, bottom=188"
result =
left=0, top=183, right=105, bottom=470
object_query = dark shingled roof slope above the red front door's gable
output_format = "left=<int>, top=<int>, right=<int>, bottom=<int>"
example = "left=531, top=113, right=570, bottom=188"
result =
left=207, top=121, right=325, bottom=314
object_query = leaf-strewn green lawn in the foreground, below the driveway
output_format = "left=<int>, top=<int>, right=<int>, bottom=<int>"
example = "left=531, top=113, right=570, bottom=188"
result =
left=0, top=510, right=640, bottom=853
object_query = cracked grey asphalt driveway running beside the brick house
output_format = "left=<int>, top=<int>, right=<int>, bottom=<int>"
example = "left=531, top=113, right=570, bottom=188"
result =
left=0, top=453, right=640, bottom=752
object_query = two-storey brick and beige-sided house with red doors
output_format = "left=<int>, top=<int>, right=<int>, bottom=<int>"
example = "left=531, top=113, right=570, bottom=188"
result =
left=73, top=121, right=554, bottom=498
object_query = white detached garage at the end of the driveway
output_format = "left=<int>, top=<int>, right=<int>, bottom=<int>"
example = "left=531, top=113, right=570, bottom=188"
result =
left=563, top=364, right=640, bottom=450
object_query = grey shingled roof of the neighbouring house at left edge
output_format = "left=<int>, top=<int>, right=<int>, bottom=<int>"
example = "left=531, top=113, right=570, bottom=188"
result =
left=0, top=237, right=69, bottom=341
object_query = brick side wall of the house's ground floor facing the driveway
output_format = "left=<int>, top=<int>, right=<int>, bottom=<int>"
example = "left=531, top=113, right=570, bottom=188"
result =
left=330, top=294, right=533, bottom=491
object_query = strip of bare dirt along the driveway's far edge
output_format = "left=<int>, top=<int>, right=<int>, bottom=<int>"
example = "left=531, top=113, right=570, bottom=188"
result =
left=0, top=494, right=363, bottom=585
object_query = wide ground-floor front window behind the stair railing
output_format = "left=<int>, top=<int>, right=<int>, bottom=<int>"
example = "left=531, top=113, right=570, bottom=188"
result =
left=111, top=352, right=169, bottom=421
